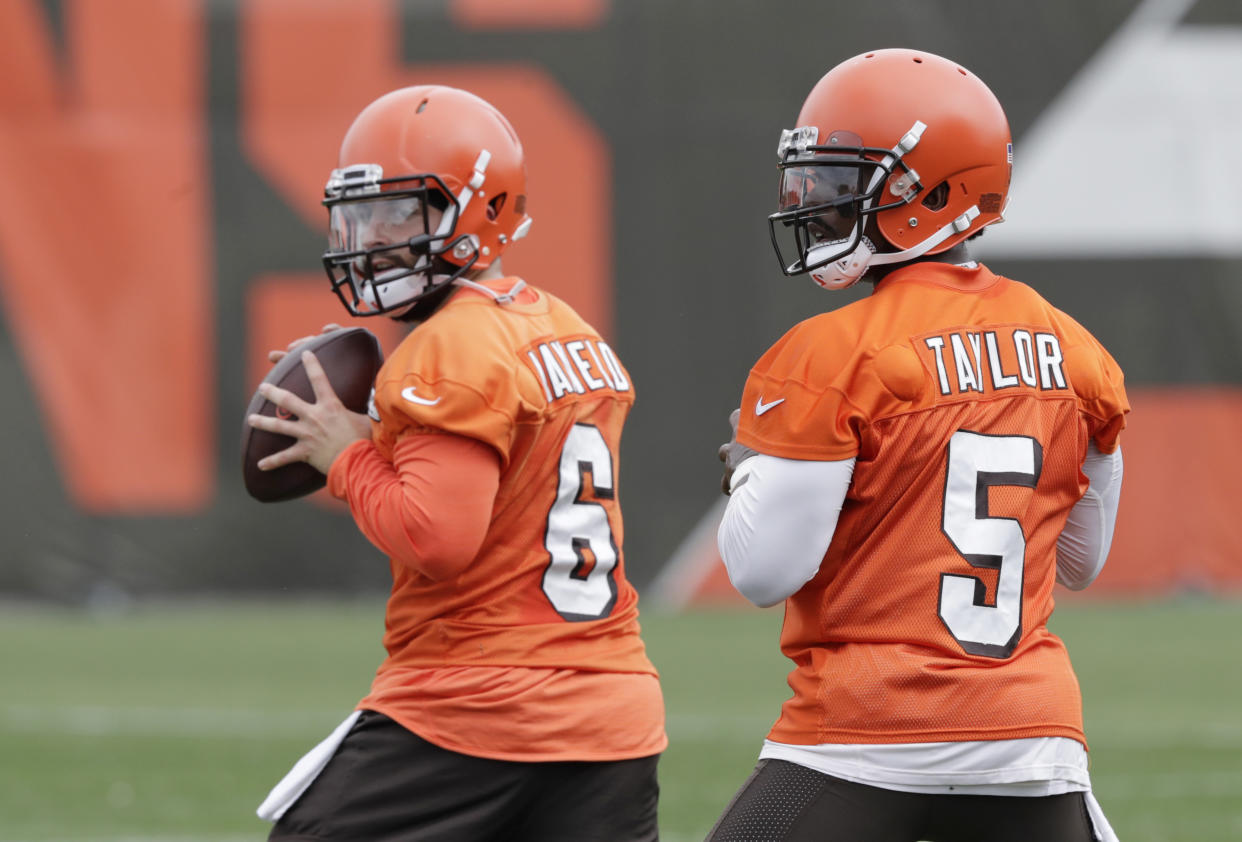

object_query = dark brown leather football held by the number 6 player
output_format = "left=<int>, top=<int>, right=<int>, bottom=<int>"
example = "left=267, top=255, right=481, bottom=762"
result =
left=241, top=328, right=384, bottom=503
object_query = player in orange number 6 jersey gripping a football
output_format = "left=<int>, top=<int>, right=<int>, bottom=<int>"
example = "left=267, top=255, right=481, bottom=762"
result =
left=251, top=86, right=667, bottom=842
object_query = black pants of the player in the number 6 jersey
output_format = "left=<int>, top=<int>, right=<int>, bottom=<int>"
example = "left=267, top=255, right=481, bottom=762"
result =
left=268, top=710, right=660, bottom=842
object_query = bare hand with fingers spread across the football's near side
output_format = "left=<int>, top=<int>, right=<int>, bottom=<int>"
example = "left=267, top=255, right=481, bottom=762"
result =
left=246, top=351, right=371, bottom=473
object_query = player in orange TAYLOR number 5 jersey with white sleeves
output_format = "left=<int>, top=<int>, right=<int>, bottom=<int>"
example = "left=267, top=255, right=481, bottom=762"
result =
left=709, top=50, right=1129, bottom=842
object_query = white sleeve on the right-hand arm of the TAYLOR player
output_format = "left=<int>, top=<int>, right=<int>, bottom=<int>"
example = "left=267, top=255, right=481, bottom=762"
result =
left=1057, top=442, right=1123, bottom=591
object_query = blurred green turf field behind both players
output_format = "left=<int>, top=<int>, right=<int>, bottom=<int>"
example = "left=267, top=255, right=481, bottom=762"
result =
left=0, top=600, right=1242, bottom=842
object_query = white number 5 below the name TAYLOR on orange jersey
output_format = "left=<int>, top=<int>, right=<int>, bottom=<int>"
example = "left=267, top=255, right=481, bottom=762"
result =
left=940, top=430, right=1043, bottom=658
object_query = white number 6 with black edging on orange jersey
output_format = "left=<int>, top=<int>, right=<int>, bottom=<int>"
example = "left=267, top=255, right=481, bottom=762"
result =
left=543, top=423, right=617, bottom=621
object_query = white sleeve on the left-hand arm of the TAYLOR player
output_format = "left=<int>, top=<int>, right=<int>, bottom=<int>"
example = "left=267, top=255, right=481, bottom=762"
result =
left=717, top=453, right=854, bottom=607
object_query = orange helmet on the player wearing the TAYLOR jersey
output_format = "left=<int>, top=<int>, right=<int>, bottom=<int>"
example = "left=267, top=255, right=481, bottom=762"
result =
left=769, top=50, right=1013, bottom=289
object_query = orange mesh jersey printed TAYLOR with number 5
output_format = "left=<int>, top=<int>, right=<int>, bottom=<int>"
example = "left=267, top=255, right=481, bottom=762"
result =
left=738, top=262, right=1129, bottom=745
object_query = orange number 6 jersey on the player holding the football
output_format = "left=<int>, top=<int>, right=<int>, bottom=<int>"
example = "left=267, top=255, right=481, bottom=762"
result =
left=333, top=278, right=666, bottom=760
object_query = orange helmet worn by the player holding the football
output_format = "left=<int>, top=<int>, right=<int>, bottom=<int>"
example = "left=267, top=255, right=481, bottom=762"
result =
left=323, top=84, right=530, bottom=317
